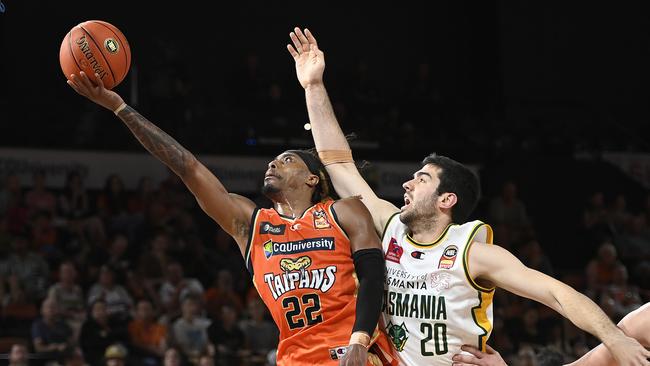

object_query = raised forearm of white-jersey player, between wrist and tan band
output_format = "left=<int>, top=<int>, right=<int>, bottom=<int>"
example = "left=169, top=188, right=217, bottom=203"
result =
left=305, top=83, right=350, bottom=151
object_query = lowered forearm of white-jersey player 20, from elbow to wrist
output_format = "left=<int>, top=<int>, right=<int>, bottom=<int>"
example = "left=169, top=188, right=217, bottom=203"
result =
left=553, top=286, right=624, bottom=345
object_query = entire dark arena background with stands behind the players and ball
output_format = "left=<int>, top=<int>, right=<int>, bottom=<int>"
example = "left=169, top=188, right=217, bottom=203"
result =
left=0, top=0, right=650, bottom=365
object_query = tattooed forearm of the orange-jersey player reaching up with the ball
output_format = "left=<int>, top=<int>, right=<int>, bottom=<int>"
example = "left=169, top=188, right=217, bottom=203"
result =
left=118, top=106, right=196, bottom=177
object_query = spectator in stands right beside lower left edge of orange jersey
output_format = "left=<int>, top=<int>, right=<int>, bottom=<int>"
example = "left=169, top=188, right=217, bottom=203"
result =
left=239, top=298, right=279, bottom=365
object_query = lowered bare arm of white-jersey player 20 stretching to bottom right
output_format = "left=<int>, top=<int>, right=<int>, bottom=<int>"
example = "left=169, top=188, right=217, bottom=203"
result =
left=469, top=243, right=650, bottom=365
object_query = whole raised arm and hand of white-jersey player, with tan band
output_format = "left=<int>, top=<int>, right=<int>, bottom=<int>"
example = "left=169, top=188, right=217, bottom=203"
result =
left=287, top=28, right=399, bottom=232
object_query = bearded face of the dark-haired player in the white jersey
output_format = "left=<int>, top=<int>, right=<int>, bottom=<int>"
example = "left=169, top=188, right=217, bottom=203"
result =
left=400, top=164, right=440, bottom=224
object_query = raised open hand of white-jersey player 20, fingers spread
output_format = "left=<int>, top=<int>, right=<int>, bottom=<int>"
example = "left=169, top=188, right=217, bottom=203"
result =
left=287, top=27, right=325, bottom=89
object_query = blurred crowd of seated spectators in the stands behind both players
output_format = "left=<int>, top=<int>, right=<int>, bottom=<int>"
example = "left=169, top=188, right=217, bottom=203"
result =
left=0, top=167, right=650, bottom=366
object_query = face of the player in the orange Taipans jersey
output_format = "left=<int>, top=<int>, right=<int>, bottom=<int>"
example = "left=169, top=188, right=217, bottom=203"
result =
left=262, top=152, right=311, bottom=199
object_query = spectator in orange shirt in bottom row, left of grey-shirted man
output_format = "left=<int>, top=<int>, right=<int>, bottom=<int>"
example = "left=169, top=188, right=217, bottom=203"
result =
left=129, top=300, right=167, bottom=364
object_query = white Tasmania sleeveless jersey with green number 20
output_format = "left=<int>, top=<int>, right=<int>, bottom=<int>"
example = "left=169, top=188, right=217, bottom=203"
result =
left=381, top=214, right=494, bottom=366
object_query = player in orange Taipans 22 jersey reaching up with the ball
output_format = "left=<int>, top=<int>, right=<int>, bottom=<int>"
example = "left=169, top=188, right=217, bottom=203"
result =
left=68, top=72, right=392, bottom=366
